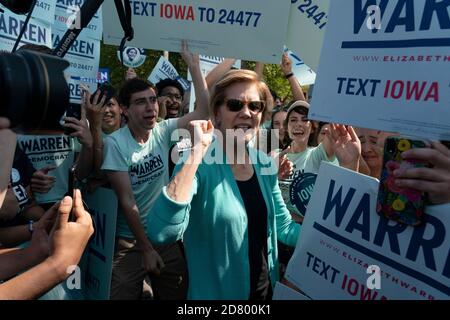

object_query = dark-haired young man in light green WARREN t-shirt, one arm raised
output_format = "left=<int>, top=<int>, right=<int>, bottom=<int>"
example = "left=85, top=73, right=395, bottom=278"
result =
left=102, top=48, right=208, bottom=299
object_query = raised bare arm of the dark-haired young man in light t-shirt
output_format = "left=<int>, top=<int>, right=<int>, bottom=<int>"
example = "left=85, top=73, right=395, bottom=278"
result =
left=177, top=41, right=209, bottom=128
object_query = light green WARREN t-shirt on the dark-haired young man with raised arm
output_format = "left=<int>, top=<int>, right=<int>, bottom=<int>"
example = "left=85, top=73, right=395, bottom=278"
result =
left=102, top=119, right=177, bottom=238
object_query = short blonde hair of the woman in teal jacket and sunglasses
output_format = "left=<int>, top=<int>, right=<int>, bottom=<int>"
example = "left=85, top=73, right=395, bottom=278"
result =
left=209, top=70, right=273, bottom=121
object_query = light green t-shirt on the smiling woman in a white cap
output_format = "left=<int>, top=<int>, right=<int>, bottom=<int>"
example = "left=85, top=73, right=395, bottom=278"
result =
left=279, top=144, right=339, bottom=214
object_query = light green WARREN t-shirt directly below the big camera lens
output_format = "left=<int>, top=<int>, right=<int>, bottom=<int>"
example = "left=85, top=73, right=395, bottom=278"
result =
left=17, top=134, right=81, bottom=204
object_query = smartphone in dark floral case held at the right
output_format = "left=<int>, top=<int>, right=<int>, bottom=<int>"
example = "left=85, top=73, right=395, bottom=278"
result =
left=377, top=136, right=429, bottom=226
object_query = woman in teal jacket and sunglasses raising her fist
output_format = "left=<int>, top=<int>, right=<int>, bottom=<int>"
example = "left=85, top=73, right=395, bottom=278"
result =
left=148, top=70, right=300, bottom=300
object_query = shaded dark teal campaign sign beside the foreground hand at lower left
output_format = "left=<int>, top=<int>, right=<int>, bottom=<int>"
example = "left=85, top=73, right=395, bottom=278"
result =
left=80, top=188, right=118, bottom=300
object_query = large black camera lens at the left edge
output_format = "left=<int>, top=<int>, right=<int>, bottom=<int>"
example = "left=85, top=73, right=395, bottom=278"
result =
left=0, top=50, right=69, bottom=130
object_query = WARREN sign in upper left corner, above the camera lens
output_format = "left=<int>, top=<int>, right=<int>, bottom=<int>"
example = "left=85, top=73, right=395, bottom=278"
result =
left=0, top=9, right=52, bottom=52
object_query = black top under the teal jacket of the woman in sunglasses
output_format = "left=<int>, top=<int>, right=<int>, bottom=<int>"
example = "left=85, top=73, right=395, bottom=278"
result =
left=236, top=173, right=272, bottom=300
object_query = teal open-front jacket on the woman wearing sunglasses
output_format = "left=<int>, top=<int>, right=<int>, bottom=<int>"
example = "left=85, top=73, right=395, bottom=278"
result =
left=147, top=141, right=300, bottom=300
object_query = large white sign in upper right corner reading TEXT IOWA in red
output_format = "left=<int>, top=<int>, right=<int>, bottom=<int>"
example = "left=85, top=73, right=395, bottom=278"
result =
left=310, top=0, right=450, bottom=140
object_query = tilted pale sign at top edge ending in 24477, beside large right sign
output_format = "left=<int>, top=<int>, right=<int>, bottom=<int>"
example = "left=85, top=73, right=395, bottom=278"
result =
left=286, top=0, right=330, bottom=71
